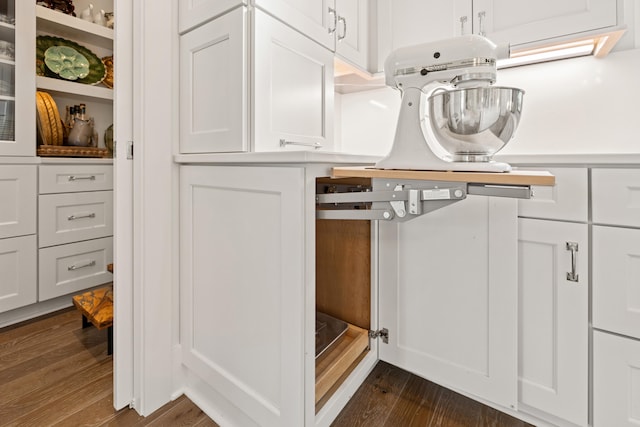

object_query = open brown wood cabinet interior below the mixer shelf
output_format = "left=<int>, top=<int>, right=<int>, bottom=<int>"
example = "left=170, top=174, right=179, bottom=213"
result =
left=315, top=178, right=371, bottom=412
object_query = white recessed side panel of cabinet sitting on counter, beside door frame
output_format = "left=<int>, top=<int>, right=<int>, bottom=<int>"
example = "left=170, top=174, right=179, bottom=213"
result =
left=180, top=7, right=248, bottom=153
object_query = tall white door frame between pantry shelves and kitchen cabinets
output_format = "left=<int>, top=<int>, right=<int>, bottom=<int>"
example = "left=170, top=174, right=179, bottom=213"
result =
left=114, top=0, right=182, bottom=416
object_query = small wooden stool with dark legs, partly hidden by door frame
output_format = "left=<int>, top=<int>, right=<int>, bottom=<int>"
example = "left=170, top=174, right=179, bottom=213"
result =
left=73, top=286, right=113, bottom=354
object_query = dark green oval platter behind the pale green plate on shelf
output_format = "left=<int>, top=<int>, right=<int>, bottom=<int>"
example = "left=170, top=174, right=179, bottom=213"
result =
left=36, top=36, right=106, bottom=85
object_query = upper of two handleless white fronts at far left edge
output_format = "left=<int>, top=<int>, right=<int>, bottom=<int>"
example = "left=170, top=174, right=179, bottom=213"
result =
left=0, top=165, right=38, bottom=239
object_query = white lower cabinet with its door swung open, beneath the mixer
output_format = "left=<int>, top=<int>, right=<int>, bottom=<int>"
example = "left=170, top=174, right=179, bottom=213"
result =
left=180, top=165, right=517, bottom=427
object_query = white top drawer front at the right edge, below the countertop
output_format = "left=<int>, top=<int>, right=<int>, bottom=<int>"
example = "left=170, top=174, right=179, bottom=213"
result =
left=591, top=169, right=640, bottom=227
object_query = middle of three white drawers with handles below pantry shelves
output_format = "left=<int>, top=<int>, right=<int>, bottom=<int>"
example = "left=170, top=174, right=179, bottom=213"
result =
left=38, top=191, right=113, bottom=248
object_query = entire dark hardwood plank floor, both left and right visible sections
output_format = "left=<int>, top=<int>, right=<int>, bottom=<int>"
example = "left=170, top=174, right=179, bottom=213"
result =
left=0, top=308, right=528, bottom=427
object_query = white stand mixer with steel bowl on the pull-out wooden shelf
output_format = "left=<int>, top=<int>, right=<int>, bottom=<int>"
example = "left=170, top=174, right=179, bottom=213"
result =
left=375, top=35, right=523, bottom=172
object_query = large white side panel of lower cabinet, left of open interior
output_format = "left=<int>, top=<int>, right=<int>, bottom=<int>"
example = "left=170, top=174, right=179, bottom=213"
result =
left=180, top=166, right=306, bottom=426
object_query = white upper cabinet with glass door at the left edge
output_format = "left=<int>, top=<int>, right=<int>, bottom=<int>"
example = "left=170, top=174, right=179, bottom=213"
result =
left=0, top=0, right=35, bottom=156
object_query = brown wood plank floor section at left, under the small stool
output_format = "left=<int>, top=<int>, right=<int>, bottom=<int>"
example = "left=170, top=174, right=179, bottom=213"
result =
left=0, top=308, right=217, bottom=427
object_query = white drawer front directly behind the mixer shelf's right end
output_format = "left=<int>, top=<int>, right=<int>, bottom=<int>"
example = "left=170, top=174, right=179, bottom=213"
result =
left=518, top=167, right=589, bottom=222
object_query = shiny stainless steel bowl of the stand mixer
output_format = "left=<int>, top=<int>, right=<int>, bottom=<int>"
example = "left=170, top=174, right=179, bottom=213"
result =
left=427, top=86, right=524, bottom=162
